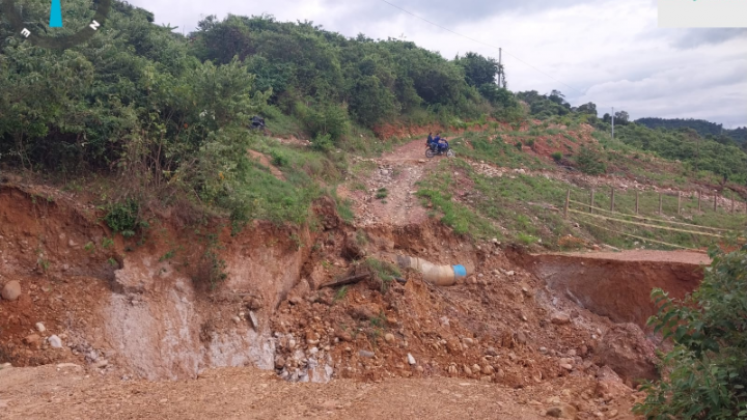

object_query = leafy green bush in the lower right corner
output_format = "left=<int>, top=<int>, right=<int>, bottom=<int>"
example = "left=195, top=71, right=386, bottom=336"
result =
left=635, top=246, right=747, bottom=420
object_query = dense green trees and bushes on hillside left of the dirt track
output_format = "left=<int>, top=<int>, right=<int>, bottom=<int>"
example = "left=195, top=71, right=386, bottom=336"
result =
left=0, top=0, right=519, bottom=226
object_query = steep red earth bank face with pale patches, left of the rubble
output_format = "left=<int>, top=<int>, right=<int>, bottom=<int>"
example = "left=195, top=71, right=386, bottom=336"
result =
left=0, top=186, right=486, bottom=381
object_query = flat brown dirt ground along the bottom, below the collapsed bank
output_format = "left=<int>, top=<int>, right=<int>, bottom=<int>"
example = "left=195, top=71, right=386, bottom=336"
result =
left=0, top=366, right=631, bottom=420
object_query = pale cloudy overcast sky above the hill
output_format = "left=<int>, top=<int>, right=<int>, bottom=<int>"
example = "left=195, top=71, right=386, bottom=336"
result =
left=130, top=0, right=747, bottom=127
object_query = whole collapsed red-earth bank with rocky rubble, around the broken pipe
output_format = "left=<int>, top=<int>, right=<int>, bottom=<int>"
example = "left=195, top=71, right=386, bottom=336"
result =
left=0, top=180, right=700, bottom=411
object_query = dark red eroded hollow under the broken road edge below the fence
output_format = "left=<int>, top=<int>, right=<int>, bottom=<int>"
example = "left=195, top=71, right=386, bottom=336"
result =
left=520, top=251, right=710, bottom=328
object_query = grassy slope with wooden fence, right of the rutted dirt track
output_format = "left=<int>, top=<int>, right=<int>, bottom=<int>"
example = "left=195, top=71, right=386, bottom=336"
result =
left=412, top=120, right=747, bottom=249
